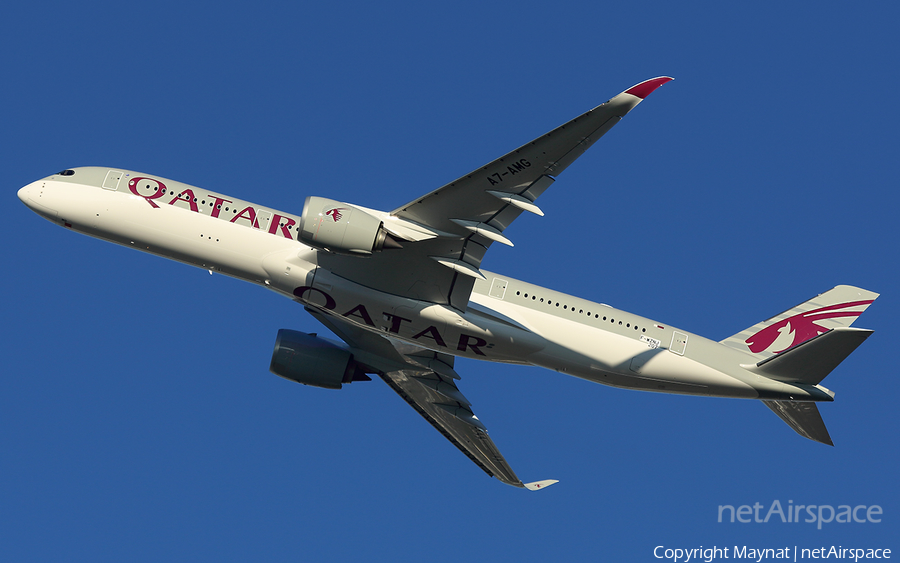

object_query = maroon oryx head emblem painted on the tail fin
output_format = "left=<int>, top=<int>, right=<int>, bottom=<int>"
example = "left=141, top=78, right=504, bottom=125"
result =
left=745, top=299, right=873, bottom=354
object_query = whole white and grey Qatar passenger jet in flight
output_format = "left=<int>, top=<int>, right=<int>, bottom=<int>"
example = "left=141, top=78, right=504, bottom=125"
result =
left=18, top=76, right=878, bottom=490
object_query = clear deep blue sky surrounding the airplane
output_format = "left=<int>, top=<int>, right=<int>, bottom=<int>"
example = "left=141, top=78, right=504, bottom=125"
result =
left=0, top=2, right=900, bottom=561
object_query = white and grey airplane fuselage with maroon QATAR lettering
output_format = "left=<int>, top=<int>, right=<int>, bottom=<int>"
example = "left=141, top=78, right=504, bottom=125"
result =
left=19, top=168, right=830, bottom=400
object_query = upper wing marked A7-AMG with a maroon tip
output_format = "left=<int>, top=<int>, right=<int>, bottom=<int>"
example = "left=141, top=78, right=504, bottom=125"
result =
left=319, top=77, right=672, bottom=311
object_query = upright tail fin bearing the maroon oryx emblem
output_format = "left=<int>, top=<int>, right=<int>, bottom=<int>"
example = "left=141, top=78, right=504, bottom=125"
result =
left=721, top=285, right=878, bottom=360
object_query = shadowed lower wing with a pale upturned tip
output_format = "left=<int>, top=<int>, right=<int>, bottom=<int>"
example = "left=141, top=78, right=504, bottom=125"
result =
left=307, top=308, right=556, bottom=490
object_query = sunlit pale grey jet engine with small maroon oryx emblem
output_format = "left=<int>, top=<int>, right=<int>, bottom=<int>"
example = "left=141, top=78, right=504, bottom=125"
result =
left=299, top=196, right=402, bottom=256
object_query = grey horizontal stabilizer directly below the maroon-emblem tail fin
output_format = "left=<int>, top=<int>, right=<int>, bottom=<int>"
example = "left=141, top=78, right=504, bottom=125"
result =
left=753, top=327, right=872, bottom=385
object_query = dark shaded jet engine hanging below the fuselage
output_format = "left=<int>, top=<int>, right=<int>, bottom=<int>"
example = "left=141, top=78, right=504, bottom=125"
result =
left=269, top=328, right=370, bottom=389
